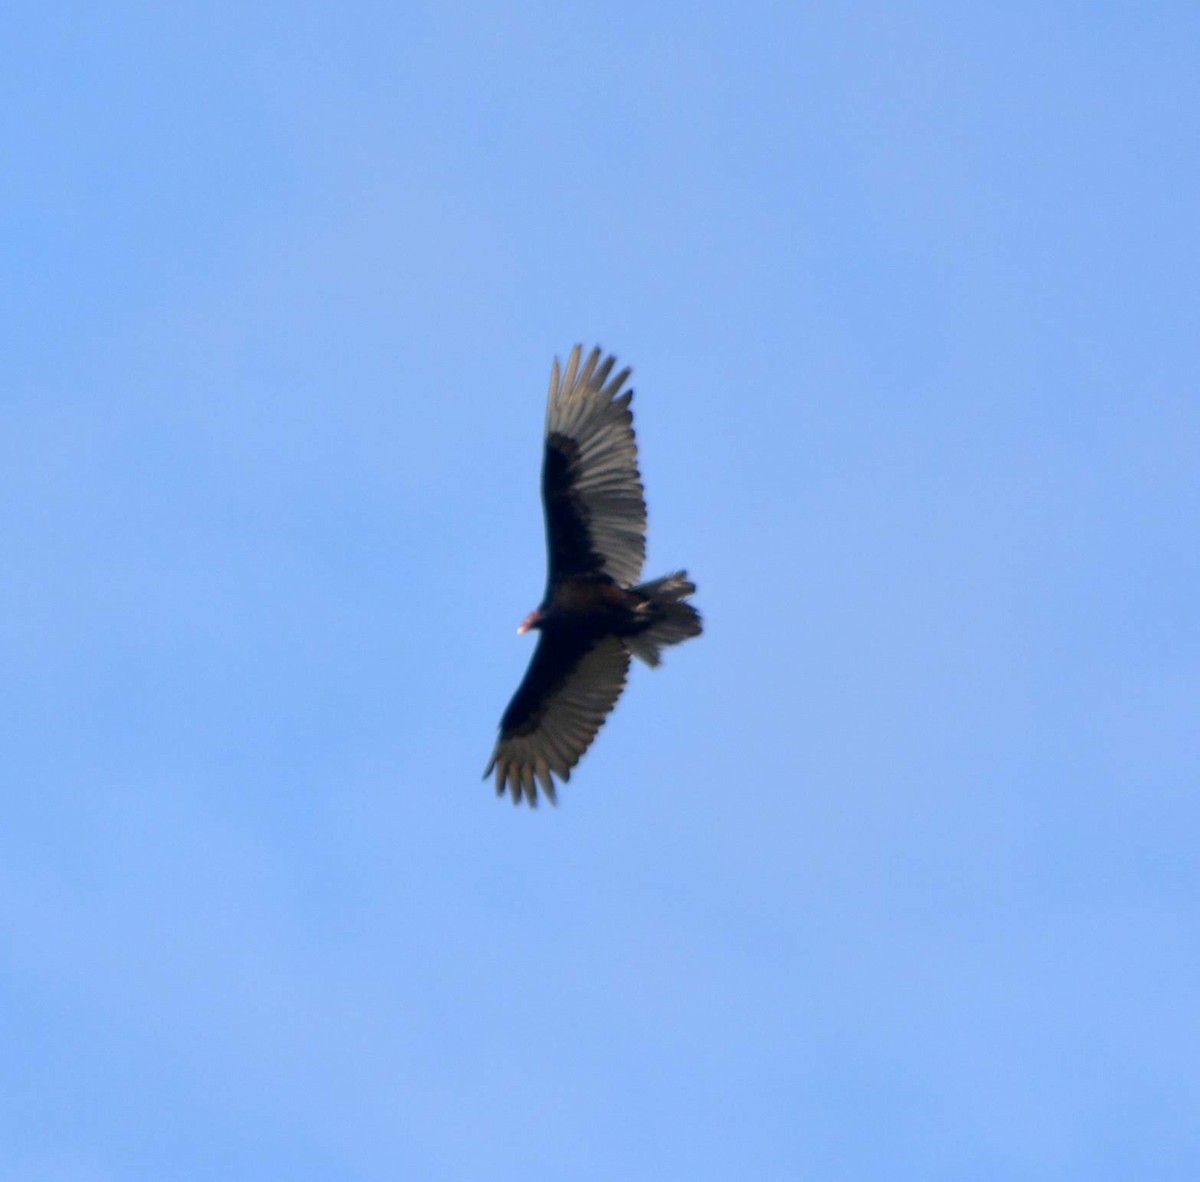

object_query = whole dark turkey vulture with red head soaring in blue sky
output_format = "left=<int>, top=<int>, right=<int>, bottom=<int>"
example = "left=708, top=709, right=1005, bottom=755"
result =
left=484, top=346, right=701, bottom=805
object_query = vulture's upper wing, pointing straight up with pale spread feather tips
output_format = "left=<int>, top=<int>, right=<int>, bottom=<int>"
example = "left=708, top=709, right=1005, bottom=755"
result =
left=541, top=346, right=646, bottom=587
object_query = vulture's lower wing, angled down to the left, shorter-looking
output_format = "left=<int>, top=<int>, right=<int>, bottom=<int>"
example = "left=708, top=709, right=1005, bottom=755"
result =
left=484, top=632, right=629, bottom=805
